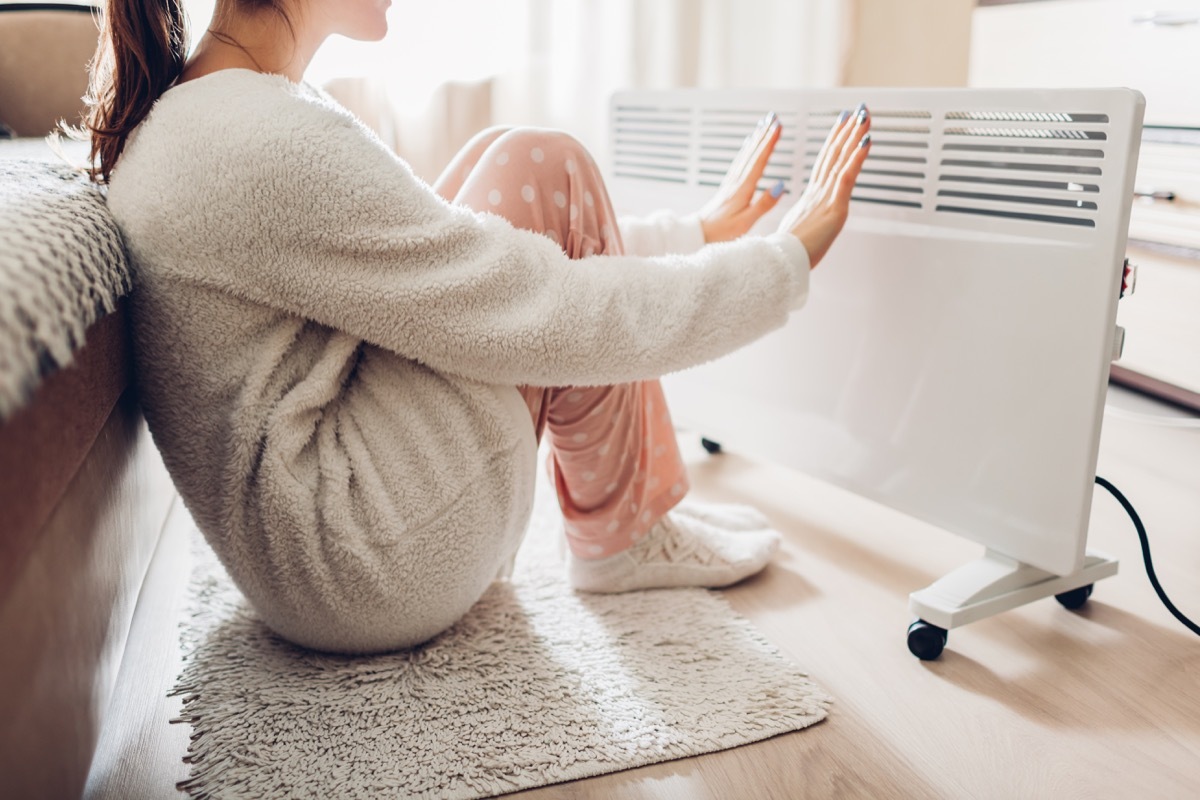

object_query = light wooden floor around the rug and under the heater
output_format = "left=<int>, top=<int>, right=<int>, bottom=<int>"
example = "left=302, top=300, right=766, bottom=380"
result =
left=89, top=386, right=1200, bottom=800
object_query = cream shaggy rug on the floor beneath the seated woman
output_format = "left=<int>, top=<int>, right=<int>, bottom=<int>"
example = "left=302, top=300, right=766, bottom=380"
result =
left=175, top=485, right=829, bottom=800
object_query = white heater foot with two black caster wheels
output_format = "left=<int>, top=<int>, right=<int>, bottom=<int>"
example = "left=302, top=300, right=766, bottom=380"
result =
left=908, top=549, right=1117, bottom=661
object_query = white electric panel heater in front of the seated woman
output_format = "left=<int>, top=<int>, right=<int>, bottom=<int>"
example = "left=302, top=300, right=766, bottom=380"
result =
left=611, top=89, right=1144, bottom=642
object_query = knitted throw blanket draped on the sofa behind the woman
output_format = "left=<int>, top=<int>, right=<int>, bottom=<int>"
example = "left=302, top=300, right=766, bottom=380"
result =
left=0, top=160, right=132, bottom=420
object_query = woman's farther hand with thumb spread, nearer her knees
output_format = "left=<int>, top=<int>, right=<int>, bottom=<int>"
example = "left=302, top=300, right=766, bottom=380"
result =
left=700, top=113, right=784, bottom=242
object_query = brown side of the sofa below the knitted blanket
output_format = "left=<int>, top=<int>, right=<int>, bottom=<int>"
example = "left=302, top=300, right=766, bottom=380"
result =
left=0, top=309, right=176, bottom=798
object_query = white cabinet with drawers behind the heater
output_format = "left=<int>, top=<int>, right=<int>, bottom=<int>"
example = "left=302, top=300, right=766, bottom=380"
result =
left=970, top=0, right=1200, bottom=408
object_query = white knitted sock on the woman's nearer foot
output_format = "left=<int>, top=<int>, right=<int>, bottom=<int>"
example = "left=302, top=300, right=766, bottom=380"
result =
left=568, top=511, right=780, bottom=594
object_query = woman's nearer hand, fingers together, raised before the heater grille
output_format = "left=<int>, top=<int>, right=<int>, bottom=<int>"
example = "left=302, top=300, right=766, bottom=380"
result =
left=779, top=104, right=871, bottom=267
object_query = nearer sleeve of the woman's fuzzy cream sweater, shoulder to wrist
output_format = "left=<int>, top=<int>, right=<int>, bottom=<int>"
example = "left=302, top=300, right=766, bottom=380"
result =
left=194, top=94, right=809, bottom=385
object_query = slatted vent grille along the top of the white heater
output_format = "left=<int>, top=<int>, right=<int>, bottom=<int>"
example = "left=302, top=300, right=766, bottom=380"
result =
left=612, top=94, right=1114, bottom=229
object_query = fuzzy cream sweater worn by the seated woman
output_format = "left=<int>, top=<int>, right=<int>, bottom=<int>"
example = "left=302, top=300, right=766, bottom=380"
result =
left=108, top=70, right=809, bottom=652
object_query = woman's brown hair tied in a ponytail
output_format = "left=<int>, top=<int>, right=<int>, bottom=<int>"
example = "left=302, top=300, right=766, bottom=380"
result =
left=84, top=0, right=292, bottom=182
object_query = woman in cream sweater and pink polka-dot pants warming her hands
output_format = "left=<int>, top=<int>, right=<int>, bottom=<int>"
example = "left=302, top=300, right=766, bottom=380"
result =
left=90, top=0, right=869, bottom=652
